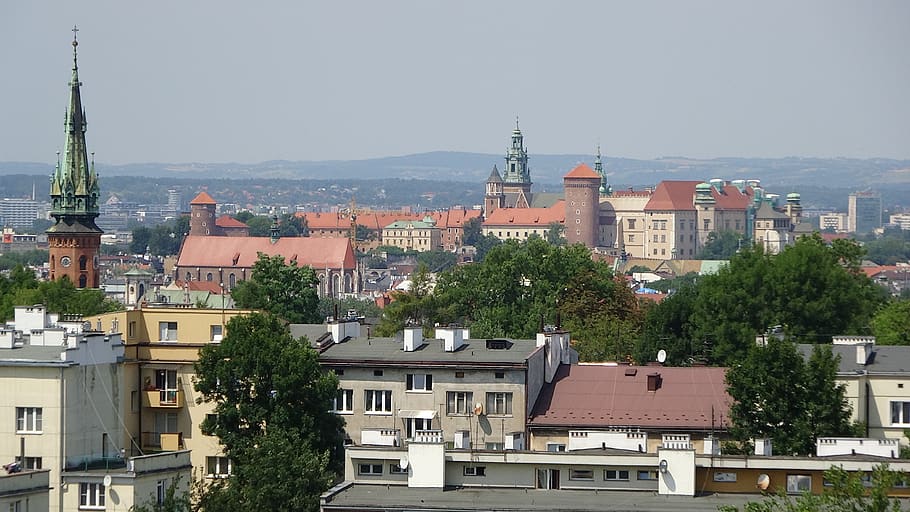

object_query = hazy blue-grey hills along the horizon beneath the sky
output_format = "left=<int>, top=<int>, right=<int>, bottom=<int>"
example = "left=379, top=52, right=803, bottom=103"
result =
left=0, top=151, right=910, bottom=190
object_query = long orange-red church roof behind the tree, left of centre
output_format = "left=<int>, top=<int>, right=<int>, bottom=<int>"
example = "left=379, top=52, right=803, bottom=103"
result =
left=177, top=235, right=355, bottom=270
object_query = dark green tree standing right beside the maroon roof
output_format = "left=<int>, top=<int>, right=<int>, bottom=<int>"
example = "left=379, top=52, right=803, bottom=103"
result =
left=726, top=336, right=853, bottom=455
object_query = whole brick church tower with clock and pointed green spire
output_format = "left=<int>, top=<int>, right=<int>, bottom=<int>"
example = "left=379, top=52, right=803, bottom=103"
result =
left=47, top=27, right=104, bottom=288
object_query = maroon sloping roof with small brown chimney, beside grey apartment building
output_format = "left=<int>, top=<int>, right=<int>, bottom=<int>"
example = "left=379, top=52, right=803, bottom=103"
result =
left=528, top=365, right=733, bottom=430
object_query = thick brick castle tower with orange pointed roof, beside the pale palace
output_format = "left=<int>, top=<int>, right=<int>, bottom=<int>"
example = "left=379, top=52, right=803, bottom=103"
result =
left=562, top=164, right=601, bottom=249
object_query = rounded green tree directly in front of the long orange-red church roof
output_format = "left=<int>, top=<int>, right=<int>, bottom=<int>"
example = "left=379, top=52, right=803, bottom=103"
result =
left=231, top=253, right=322, bottom=323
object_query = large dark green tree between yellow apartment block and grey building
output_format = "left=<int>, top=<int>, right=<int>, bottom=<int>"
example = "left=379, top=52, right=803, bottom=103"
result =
left=194, top=313, right=344, bottom=511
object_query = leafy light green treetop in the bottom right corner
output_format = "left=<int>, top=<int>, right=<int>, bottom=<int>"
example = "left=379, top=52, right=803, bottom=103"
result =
left=718, top=464, right=906, bottom=512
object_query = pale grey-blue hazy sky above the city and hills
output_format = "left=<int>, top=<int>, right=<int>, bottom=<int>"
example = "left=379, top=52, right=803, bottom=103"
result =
left=0, top=0, right=910, bottom=163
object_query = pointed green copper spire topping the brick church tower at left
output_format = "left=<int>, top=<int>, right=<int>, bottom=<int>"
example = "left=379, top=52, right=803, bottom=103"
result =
left=50, top=27, right=100, bottom=227
